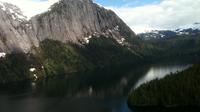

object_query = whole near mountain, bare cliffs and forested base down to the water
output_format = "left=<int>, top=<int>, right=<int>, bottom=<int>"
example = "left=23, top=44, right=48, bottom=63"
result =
left=0, top=0, right=140, bottom=83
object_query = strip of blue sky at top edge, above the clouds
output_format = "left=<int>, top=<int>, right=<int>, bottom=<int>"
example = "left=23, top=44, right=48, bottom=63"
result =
left=93, top=0, right=161, bottom=7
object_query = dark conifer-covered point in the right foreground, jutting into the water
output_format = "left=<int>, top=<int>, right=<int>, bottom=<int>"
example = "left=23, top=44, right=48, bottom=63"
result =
left=129, top=64, right=200, bottom=106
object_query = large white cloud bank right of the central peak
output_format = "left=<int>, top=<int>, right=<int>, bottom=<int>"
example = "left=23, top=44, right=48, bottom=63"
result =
left=107, top=0, right=200, bottom=33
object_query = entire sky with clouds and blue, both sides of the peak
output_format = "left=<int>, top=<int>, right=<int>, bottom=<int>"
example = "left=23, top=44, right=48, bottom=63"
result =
left=0, top=0, right=200, bottom=33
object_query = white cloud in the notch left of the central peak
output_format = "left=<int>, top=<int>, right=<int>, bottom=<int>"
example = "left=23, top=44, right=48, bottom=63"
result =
left=0, top=0, right=59, bottom=18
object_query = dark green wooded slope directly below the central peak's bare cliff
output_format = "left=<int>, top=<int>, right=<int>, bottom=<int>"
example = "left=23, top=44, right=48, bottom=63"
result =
left=40, top=37, right=137, bottom=76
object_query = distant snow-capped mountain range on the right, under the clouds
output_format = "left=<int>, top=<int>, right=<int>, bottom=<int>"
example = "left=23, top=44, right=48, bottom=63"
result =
left=138, top=23, right=200, bottom=40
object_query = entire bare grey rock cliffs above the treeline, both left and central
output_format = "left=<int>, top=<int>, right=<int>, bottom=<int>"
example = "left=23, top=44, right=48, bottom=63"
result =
left=0, top=0, right=135, bottom=52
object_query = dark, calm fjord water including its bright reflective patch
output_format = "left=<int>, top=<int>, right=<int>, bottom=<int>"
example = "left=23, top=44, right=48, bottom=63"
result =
left=0, top=64, right=189, bottom=112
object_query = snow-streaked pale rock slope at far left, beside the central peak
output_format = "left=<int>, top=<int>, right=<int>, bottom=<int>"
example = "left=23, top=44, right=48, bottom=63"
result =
left=0, top=2, right=38, bottom=53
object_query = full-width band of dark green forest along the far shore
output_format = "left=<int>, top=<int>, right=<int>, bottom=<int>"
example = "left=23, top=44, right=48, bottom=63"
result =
left=0, top=33, right=200, bottom=82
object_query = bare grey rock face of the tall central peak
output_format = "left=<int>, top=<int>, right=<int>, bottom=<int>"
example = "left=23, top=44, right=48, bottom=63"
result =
left=31, top=0, right=134, bottom=43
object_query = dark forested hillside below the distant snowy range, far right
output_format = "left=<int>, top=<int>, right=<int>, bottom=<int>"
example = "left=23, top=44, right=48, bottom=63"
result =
left=132, top=35, right=200, bottom=61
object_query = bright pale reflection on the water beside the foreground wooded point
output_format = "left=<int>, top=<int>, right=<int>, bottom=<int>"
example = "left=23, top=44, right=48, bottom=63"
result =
left=134, top=65, right=191, bottom=88
